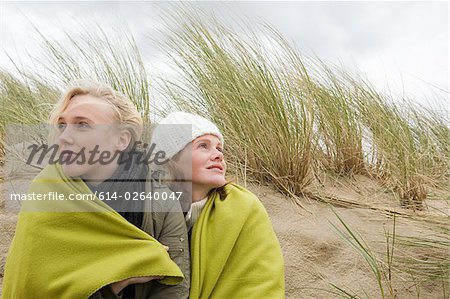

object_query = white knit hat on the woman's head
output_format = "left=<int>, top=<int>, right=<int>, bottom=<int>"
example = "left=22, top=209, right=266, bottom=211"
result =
left=151, top=112, right=223, bottom=159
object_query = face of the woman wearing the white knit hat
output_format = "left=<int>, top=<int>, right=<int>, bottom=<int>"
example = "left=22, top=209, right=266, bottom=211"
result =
left=177, top=135, right=227, bottom=196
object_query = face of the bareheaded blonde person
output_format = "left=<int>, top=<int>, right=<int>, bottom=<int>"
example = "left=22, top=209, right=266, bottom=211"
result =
left=56, top=95, right=131, bottom=185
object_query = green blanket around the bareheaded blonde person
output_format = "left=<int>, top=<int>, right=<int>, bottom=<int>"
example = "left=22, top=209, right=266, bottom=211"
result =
left=2, top=165, right=183, bottom=299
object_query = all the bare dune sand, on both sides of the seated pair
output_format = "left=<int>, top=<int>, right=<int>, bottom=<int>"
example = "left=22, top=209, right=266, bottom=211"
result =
left=0, top=168, right=449, bottom=299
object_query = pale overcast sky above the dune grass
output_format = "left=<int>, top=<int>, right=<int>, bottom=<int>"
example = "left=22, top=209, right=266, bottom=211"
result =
left=0, top=1, right=450, bottom=111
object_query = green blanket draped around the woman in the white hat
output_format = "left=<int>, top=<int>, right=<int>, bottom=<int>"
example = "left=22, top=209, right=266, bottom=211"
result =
left=190, top=184, right=284, bottom=299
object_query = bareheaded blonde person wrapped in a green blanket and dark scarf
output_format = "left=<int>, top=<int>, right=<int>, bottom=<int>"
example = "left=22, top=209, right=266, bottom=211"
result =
left=2, top=81, right=189, bottom=298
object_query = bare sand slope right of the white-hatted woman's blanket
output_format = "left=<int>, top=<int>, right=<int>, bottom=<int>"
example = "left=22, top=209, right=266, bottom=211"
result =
left=255, top=186, right=448, bottom=298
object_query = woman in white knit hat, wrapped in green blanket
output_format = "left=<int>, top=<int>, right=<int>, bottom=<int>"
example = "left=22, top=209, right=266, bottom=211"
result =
left=152, top=112, right=284, bottom=299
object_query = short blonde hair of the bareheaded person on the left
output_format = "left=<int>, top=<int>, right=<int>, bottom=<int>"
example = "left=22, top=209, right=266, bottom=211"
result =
left=49, top=80, right=143, bottom=144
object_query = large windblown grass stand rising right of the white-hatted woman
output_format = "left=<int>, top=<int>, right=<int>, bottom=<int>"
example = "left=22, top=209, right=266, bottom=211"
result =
left=157, top=13, right=449, bottom=210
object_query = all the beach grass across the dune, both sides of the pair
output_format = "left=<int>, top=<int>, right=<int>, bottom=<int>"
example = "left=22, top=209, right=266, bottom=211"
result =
left=0, top=9, right=450, bottom=298
